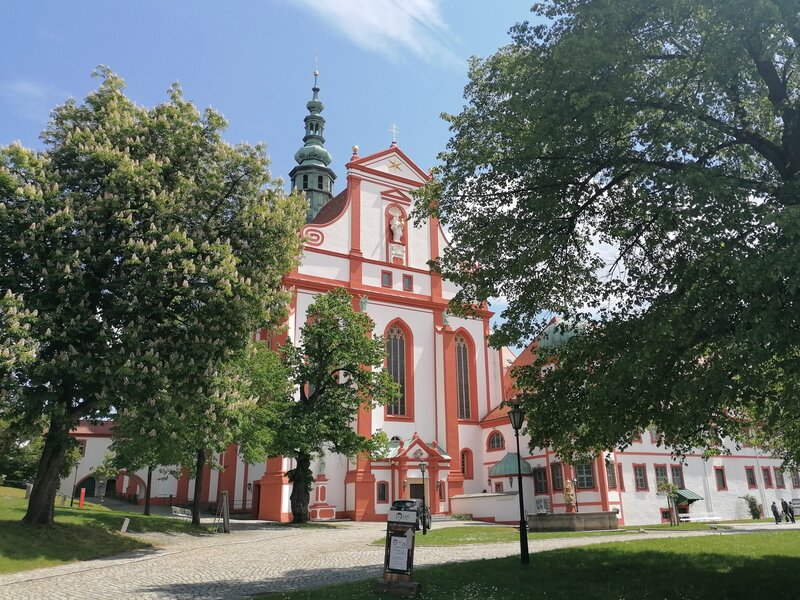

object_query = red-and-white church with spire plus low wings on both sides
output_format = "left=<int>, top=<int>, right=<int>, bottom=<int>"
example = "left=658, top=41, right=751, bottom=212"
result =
left=60, top=73, right=800, bottom=525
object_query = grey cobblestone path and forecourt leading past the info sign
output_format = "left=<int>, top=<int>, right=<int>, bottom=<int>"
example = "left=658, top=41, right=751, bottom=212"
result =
left=0, top=522, right=788, bottom=600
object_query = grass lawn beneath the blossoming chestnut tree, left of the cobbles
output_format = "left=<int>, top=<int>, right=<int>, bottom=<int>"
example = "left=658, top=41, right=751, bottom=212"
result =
left=0, top=487, right=209, bottom=573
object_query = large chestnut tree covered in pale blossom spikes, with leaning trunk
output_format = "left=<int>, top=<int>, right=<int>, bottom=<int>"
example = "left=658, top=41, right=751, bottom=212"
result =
left=0, top=68, right=304, bottom=524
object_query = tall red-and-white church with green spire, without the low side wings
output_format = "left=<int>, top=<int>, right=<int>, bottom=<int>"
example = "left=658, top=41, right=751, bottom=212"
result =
left=253, top=73, right=503, bottom=520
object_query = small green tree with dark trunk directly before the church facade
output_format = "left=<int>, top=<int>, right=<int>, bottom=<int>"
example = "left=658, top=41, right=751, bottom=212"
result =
left=268, top=289, right=398, bottom=523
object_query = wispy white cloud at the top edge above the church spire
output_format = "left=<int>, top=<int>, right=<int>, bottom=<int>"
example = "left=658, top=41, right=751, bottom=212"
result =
left=291, top=0, right=465, bottom=68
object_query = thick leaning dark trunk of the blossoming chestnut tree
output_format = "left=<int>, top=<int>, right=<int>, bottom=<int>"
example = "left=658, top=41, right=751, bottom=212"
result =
left=22, top=415, right=75, bottom=525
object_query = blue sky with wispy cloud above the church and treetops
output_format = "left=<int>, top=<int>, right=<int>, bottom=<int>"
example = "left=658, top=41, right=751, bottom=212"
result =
left=0, top=0, right=532, bottom=191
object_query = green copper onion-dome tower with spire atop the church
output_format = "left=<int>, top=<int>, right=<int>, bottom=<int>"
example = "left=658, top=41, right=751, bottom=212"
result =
left=289, top=71, right=336, bottom=223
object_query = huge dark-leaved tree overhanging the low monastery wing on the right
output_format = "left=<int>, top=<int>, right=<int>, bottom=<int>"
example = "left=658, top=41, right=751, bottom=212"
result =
left=420, top=0, right=800, bottom=459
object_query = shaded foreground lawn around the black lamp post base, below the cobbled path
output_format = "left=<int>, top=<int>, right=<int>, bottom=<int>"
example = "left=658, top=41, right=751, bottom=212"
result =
left=262, top=531, right=800, bottom=600
